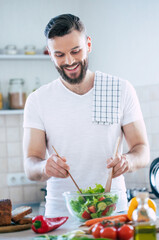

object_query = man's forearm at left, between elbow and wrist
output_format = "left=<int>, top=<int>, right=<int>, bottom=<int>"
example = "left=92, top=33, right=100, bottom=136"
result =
left=24, top=157, right=49, bottom=181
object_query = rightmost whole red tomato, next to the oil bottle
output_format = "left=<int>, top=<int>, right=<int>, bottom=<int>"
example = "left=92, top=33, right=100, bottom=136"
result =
left=117, top=224, right=134, bottom=240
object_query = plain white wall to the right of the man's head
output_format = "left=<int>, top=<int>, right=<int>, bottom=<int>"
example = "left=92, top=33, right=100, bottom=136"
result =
left=82, top=0, right=159, bottom=86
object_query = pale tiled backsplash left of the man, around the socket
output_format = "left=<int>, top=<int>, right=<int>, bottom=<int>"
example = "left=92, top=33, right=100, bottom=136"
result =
left=0, top=115, right=45, bottom=204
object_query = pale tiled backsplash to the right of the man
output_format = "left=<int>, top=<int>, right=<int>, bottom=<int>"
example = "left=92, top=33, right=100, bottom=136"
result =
left=125, top=84, right=159, bottom=190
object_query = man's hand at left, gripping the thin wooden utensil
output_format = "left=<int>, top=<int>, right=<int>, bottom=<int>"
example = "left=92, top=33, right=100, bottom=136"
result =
left=44, top=154, right=70, bottom=178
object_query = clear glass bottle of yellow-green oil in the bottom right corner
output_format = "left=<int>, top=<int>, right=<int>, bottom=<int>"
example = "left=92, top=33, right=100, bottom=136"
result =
left=132, top=192, right=157, bottom=240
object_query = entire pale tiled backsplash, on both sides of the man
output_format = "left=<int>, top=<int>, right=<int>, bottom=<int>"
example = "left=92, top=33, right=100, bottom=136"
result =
left=0, top=85, right=159, bottom=204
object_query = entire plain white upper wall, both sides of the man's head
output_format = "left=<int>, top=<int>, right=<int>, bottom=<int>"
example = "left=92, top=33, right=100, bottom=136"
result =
left=0, top=0, right=159, bottom=94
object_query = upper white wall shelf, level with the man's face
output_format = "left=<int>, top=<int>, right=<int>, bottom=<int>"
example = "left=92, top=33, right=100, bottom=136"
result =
left=0, top=54, right=50, bottom=60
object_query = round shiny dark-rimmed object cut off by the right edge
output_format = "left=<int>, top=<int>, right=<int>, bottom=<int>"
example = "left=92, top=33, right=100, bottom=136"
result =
left=149, top=158, right=159, bottom=198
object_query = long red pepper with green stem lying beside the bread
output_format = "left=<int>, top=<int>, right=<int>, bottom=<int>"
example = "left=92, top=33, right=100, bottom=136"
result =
left=32, top=215, right=68, bottom=233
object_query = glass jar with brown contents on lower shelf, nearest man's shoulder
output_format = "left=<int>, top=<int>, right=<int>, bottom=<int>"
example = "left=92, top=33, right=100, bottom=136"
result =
left=9, top=78, right=26, bottom=109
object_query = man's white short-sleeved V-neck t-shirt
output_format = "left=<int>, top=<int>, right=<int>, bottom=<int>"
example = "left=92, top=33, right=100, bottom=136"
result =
left=24, top=71, right=142, bottom=216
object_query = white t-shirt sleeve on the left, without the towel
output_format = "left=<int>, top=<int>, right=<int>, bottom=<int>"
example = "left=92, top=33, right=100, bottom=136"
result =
left=23, top=91, right=45, bottom=131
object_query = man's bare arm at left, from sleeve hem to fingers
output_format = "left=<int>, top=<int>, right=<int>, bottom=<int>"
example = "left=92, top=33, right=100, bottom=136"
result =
left=23, top=128, right=69, bottom=181
